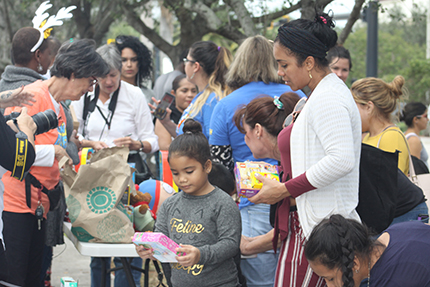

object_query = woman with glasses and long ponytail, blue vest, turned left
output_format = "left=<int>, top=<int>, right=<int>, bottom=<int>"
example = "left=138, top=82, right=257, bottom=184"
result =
left=176, top=41, right=232, bottom=138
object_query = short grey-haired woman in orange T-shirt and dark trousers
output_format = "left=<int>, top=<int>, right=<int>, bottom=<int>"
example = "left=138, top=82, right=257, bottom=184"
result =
left=3, top=40, right=109, bottom=286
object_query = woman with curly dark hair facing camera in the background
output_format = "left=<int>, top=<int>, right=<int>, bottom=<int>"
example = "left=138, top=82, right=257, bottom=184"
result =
left=115, top=35, right=155, bottom=103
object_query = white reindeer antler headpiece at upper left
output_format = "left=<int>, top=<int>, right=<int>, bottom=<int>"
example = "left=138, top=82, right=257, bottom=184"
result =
left=31, top=0, right=76, bottom=53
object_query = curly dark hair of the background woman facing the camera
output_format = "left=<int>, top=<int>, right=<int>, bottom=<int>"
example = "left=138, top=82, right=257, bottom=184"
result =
left=115, top=35, right=152, bottom=85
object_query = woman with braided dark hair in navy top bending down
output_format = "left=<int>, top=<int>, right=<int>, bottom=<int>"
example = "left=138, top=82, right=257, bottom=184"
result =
left=305, top=215, right=430, bottom=287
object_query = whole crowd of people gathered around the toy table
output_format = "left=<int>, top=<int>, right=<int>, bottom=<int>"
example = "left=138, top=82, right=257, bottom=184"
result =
left=0, top=5, right=430, bottom=287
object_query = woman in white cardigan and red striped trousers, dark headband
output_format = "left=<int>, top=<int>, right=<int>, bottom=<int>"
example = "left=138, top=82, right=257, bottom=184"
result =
left=250, top=13, right=361, bottom=286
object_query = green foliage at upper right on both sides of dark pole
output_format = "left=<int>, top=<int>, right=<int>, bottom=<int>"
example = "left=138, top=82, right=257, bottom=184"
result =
left=345, top=3, right=430, bottom=104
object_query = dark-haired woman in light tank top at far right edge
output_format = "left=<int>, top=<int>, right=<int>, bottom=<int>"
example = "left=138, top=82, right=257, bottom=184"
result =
left=400, top=102, right=429, bottom=167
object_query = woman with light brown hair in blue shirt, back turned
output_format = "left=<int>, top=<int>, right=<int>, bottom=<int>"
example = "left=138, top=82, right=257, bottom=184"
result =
left=209, top=35, right=305, bottom=287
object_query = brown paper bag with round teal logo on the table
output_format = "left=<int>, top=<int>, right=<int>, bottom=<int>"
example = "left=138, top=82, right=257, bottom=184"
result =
left=60, top=147, right=134, bottom=243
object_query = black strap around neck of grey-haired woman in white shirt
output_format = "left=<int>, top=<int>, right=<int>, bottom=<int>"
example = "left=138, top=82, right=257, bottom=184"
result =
left=82, top=82, right=121, bottom=137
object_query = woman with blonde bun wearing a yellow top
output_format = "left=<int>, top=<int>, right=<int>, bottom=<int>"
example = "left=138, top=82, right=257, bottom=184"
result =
left=351, top=76, right=428, bottom=227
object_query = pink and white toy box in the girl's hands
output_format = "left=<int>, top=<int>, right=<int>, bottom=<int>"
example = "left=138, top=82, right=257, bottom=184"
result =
left=133, top=232, right=185, bottom=263
